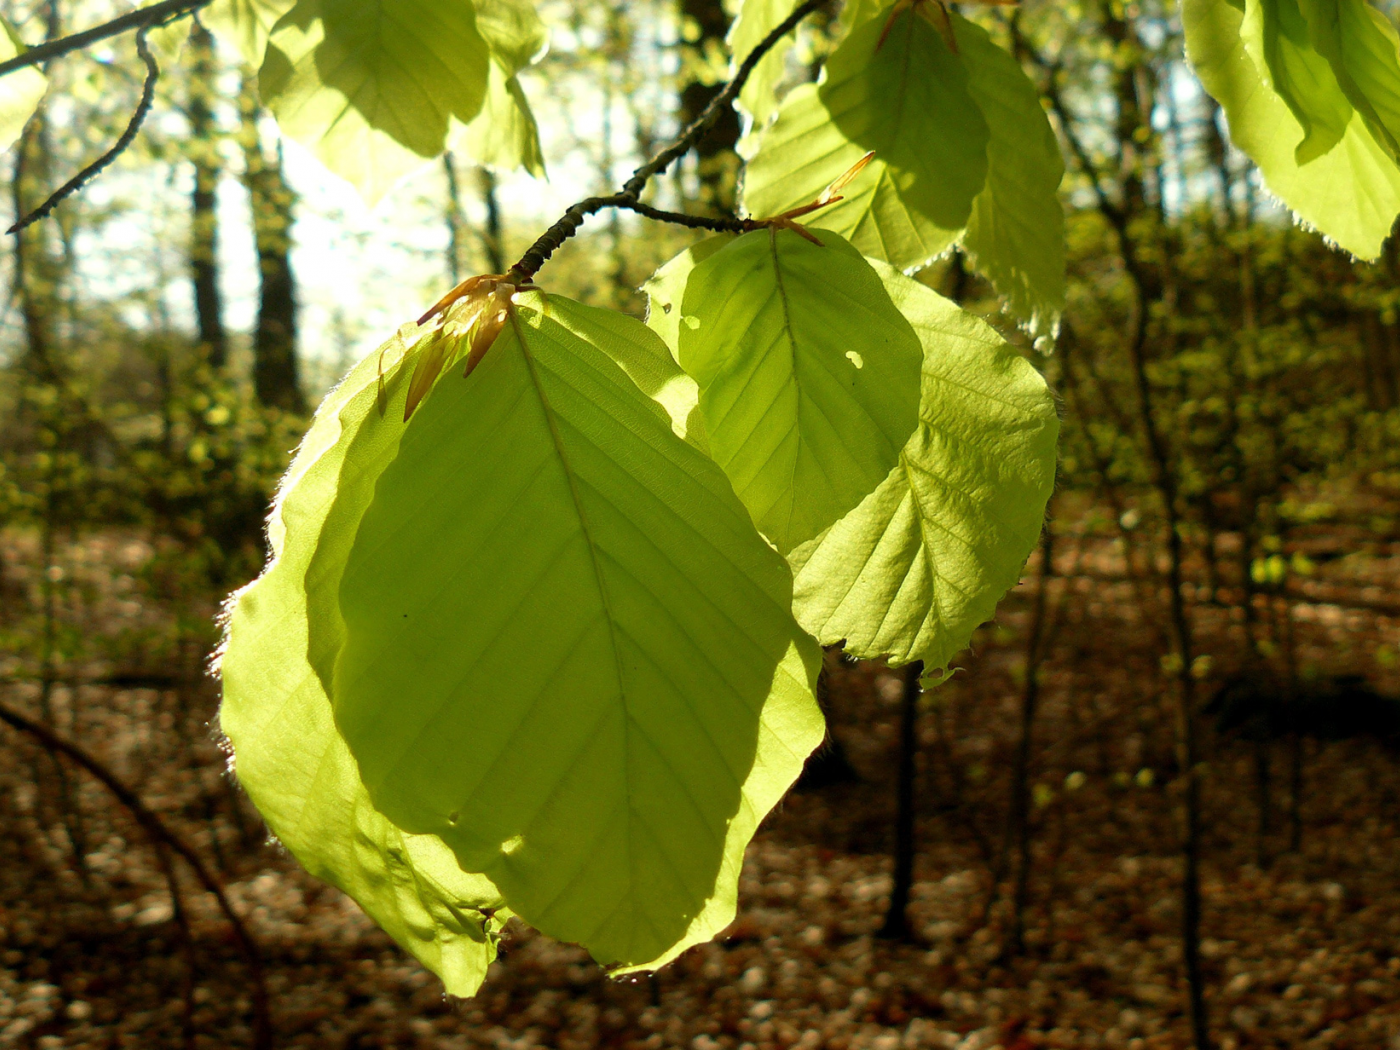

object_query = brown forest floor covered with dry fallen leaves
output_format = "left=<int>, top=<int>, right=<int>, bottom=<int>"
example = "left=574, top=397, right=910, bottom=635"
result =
left=0, top=520, right=1400, bottom=1050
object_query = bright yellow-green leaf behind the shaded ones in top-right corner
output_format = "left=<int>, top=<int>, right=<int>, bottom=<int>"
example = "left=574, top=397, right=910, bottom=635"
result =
left=1182, top=0, right=1400, bottom=259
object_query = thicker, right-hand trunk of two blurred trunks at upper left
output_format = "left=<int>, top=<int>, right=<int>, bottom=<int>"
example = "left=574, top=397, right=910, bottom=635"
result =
left=239, top=77, right=305, bottom=413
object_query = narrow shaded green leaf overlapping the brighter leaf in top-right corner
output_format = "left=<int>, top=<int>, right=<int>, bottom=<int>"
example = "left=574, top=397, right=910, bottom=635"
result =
left=1240, top=0, right=1352, bottom=165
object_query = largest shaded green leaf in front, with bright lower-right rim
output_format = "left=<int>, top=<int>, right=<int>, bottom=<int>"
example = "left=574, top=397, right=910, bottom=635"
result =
left=316, top=295, right=823, bottom=967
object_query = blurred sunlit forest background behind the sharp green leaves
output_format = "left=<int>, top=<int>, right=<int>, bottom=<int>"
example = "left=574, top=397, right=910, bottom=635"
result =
left=0, top=0, right=1400, bottom=1050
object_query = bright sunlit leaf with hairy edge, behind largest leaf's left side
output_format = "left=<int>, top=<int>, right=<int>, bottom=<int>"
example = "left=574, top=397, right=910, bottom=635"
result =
left=220, top=334, right=510, bottom=995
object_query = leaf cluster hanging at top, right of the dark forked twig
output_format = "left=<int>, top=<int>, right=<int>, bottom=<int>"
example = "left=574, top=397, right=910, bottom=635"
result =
left=745, top=3, right=1064, bottom=335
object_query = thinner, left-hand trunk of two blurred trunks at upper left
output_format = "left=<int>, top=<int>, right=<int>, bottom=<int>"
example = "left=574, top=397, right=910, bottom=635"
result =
left=189, top=22, right=228, bottom=368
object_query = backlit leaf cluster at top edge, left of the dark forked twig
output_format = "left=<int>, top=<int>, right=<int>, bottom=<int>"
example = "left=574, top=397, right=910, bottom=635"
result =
left=202, top=0, right=547, bottom=186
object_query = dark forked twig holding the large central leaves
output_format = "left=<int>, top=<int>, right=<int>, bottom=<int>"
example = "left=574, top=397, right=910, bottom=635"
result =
left=511, top=0, right=826, bottom=281
